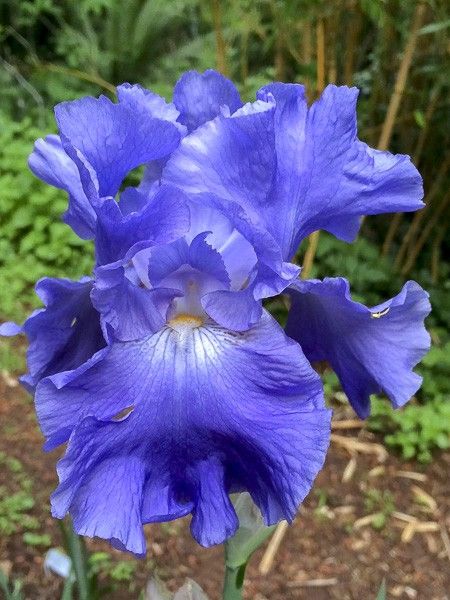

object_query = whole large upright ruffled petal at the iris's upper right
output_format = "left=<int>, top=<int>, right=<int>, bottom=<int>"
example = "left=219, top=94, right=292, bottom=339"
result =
left=163, top=83, right=423, bottom=260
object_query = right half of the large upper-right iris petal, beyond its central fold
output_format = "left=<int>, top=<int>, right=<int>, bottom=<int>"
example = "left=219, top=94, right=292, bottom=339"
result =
left=259, top=84, right=423, bottom=257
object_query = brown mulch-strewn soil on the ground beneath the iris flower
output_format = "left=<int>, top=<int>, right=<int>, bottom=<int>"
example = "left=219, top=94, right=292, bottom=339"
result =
left=0, top=376, right=450, bottom=600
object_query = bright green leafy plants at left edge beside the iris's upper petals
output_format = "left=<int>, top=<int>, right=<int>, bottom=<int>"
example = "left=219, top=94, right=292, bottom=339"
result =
left=0, top=111, right=92, bottom=328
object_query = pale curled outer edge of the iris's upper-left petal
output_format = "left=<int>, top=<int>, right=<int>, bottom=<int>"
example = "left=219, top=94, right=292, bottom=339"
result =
left=28, top=135, right=96, bottom=239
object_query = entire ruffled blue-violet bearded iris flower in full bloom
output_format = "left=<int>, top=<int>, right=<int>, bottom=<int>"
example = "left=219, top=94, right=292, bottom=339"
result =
left=1, top=71, right=430, bottom=555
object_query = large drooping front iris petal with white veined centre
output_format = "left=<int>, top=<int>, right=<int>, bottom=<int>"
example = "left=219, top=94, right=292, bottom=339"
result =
left=40, top=313, right=330, bottom=554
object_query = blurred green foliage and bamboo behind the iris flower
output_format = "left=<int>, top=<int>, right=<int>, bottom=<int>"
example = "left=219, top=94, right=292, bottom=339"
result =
left=0, top=0, right=450, bottom=461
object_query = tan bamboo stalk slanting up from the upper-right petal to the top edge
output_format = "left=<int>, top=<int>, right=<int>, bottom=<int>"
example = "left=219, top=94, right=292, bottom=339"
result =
left=378, top=2, right=426, bottom=150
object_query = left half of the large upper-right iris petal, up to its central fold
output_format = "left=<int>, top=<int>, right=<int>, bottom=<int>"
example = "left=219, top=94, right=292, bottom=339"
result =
left=163, top=102, right=276, bottom=224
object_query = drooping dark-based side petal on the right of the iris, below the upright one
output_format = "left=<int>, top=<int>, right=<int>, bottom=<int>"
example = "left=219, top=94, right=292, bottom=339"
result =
left=286, top=277, right=431, bottom=418
